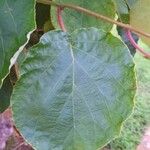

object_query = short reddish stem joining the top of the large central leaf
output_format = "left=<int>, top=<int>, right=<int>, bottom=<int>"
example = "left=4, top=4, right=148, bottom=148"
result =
left=57, top=7, right=66, bottom=32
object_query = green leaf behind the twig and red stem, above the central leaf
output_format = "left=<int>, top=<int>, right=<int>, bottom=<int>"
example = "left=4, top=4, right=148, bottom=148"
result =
left=52, top=0, right=115, bottom=31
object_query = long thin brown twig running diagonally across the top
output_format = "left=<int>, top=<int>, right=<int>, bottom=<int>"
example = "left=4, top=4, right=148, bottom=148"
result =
left=36, top=0, right=150, bottom=38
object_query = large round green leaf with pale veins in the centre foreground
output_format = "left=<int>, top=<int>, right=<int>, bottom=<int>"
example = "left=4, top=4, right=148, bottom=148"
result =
left=11, top=28, right=135, bottom=150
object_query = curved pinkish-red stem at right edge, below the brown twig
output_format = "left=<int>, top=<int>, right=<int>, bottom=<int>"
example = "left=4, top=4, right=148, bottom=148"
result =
left=126, top=29, right=150, bottom=59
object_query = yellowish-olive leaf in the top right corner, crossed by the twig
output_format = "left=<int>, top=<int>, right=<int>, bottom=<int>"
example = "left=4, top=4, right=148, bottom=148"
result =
left=130, top=0, right=150, bottom=46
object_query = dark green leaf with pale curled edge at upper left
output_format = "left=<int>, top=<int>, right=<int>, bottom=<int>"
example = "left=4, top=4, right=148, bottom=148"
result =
left=0, top=0, right=34, bottom=85
